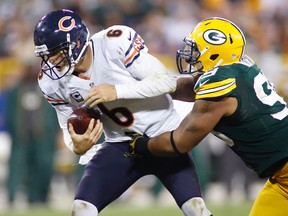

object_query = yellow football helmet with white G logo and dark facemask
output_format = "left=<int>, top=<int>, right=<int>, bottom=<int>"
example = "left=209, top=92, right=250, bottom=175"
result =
left=176, top=17, right=246, bottom=74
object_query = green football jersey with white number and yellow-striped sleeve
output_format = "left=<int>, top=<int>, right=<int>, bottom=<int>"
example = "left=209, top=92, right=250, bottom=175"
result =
left=194, top=57, right=288, bottom=177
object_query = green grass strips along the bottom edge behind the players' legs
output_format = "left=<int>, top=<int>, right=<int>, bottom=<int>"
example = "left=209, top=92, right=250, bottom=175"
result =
left=0, top=203, right=251, bottom=216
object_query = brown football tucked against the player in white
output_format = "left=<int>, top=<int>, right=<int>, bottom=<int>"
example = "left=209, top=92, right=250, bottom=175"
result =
left=67, top=106, right=101, bottom=134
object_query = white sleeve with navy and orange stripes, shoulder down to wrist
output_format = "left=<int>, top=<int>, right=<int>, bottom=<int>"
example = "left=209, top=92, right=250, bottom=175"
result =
left=103, top=26, right=176, bottom=99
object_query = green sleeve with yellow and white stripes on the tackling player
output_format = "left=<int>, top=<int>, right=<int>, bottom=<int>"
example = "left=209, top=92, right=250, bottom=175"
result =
left=194, top=68, right=237, bottom=100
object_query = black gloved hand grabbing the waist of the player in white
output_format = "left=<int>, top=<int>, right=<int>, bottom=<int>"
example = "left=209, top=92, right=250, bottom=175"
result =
left=124, top=132, right=152, bottom=159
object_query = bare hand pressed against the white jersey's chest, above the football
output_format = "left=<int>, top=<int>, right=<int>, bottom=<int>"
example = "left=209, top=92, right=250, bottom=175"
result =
left=85, top=83, right=117, bottom=107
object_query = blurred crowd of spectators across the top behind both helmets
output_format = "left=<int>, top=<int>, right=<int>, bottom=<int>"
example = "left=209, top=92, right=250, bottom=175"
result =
left=0, top=0, right=288, bottom=93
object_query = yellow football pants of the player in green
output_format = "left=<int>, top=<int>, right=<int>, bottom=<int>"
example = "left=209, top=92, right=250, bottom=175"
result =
left=249, top=163, right=288, bottom=216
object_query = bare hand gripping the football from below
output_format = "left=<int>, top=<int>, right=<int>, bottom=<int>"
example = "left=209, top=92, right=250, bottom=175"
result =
left=68, top=119, right=103, bottom=155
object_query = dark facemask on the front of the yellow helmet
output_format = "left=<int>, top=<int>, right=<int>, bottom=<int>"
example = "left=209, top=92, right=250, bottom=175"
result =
left=176, top=37, right=203, bottom=74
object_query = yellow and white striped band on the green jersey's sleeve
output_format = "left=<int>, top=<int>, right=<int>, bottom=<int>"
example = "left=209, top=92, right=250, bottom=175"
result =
left=195, top=78, right=236, bottom=99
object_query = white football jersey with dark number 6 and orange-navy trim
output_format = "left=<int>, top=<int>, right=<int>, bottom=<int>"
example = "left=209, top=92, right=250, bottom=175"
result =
left=39, top=25, right=180, bottom=160
